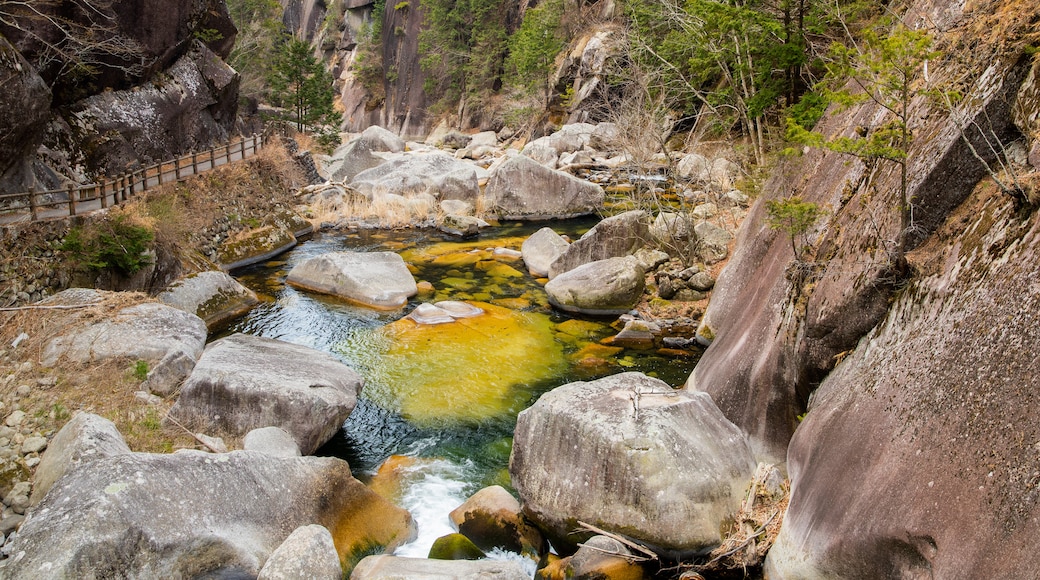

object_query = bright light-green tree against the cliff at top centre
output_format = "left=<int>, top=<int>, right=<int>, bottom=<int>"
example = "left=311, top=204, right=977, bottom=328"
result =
left=505, top=0, right=566, bottom=104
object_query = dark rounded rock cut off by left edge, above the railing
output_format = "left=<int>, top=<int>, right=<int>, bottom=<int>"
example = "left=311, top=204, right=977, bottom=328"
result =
left=0, top=34, right=51, bottom=193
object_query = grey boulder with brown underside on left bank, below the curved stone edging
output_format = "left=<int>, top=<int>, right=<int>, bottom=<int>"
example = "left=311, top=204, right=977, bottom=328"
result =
left=156, top=270, right=260, bottom=328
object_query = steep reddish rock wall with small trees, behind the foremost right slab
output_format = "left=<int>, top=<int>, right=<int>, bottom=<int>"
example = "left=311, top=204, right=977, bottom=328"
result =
left=690, top=0, right=1031, bottom=460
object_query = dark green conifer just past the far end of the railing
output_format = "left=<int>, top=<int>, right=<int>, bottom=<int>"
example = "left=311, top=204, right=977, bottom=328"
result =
left=269, top=38, right=342, bottom=131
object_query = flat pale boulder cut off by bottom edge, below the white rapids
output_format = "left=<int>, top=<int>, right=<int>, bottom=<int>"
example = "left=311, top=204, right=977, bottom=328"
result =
left=350, top=555, right=530, bottom=580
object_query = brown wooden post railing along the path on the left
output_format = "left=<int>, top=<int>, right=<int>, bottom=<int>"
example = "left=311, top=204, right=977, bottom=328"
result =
left=0, top=135, right=264, bottom=223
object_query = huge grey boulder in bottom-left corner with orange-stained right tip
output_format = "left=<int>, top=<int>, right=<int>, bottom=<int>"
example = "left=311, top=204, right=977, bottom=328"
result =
left=0, top=451, right=414, bottom=579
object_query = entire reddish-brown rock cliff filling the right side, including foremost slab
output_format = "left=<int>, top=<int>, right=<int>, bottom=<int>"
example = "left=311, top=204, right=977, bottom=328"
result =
left=690, top=0, right=1040, bottom=580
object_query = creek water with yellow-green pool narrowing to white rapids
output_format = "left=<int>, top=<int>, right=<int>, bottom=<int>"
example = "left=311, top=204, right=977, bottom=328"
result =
left=223, top=219, right=697, bottom=557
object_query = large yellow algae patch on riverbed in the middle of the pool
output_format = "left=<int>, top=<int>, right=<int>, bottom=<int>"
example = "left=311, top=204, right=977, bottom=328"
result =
left=364, top=302, right=567, bottom=426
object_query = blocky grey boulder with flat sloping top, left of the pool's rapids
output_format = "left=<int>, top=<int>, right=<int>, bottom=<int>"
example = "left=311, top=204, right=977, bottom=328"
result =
left=170, top=334, right=364, bottom=454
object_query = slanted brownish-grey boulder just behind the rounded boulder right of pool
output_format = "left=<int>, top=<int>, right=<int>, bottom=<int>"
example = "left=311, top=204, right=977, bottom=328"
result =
left=549, top=210, right=650, bottom=280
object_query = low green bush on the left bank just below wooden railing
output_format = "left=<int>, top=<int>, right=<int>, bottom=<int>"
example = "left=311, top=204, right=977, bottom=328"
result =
left=60, top=214, right=155, bottom=275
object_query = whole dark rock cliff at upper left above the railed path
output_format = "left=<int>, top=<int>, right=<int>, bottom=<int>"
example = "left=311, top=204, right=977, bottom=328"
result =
left=0, top=0, right=238, bottom=192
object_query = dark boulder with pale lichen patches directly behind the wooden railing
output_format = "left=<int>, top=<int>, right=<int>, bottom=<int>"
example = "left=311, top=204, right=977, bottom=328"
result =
left=69, top=41, right=239, bottom=174
